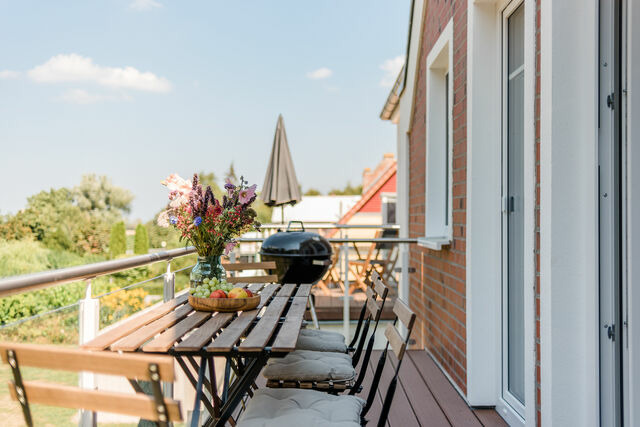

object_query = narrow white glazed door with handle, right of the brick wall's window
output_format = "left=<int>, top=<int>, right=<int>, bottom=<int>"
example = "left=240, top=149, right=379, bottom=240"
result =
left=502, top=1, right=525, bottom=417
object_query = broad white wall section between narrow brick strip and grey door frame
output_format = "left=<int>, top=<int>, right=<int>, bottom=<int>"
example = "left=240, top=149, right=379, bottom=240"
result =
left=540, top=0, right=599, bottom=426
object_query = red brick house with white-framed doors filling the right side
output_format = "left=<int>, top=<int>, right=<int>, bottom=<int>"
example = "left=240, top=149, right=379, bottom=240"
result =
left=381, top=0, right=640, bottom=426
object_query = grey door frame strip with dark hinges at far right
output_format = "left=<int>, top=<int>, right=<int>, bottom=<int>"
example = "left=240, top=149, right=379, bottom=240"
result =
left=598, top=0, right=626, bottom=427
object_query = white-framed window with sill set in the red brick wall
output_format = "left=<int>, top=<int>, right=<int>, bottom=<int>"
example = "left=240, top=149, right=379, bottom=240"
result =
left=418, top=21, right=454, bottom=250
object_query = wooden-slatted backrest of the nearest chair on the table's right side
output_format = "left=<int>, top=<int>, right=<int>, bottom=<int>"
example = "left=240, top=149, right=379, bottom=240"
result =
left=362, top=299, right=416, bottom=427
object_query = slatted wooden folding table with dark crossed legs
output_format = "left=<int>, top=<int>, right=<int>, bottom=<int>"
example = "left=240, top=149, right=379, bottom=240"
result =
left=82, top=283, right=311, bottom=426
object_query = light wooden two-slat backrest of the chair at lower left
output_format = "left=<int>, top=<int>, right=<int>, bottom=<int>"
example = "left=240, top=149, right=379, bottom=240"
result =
left=0, top=342, right=182, bottom=426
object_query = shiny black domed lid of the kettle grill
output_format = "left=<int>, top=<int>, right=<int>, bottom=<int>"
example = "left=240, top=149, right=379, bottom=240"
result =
left=260, top=221, right=333, bottom=258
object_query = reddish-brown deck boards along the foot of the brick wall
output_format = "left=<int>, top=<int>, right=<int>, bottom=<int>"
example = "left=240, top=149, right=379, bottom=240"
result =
left=248, top=350, right=507, bottom=427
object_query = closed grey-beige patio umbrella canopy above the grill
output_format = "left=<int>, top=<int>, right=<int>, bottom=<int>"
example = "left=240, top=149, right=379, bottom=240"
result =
left=260, top=115, right=302, bottom=206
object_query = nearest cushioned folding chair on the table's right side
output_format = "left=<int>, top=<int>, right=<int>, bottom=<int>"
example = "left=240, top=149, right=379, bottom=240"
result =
left=237, top=300, right=416, bottom=427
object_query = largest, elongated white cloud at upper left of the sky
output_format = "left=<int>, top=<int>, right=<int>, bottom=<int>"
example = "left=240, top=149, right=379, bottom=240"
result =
left=28, top=53, right=171, bottom=93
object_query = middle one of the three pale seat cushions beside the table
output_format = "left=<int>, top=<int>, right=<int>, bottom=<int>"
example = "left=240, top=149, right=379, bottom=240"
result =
left=262, top=350, right=356, bottom=381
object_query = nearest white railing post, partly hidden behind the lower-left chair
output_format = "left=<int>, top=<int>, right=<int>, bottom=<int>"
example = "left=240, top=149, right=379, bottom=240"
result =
left=78, top=279, right=100, bottom=427
